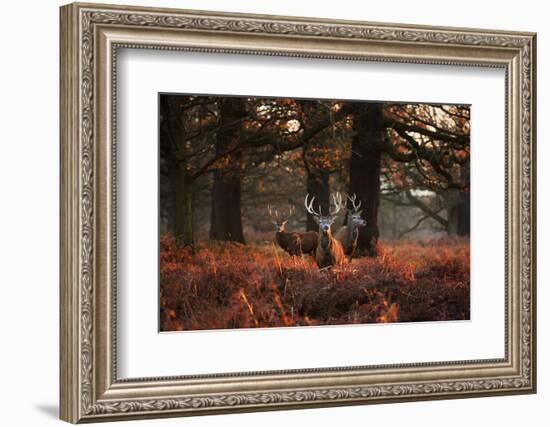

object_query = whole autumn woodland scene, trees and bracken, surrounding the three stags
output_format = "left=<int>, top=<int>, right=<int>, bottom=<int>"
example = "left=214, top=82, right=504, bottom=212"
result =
left=159, top=94, right=470, bottom=331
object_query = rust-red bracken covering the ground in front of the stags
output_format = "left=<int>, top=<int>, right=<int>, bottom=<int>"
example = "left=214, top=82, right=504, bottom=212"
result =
left=160, top=236, right=470, bottom=331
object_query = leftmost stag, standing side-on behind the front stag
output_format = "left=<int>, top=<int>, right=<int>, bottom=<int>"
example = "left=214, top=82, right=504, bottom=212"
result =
left=267, top=205, right=318, bottom=256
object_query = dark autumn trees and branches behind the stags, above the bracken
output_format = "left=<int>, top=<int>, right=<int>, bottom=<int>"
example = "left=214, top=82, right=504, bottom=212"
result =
left=159, top=94, right=470, bottom=256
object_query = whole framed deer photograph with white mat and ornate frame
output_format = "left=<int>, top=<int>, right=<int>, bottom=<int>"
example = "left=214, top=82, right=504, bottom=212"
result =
left=60, top=4, right=536, bottom=423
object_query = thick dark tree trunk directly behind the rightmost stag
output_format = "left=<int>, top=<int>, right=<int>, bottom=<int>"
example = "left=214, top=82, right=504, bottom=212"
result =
left=349, top=103, right=384, bottom=256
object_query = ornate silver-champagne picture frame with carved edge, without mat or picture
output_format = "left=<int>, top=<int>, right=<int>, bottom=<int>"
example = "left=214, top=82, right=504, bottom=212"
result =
left=60, top=4, right=536, bottom=423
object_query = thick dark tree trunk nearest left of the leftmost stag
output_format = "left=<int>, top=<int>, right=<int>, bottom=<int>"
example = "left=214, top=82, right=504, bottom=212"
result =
left=210, top=98, right=247, bottom=243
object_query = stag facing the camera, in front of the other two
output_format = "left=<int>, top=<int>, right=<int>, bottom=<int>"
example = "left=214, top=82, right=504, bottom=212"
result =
left=304, top=193, right=346, bottom=269
